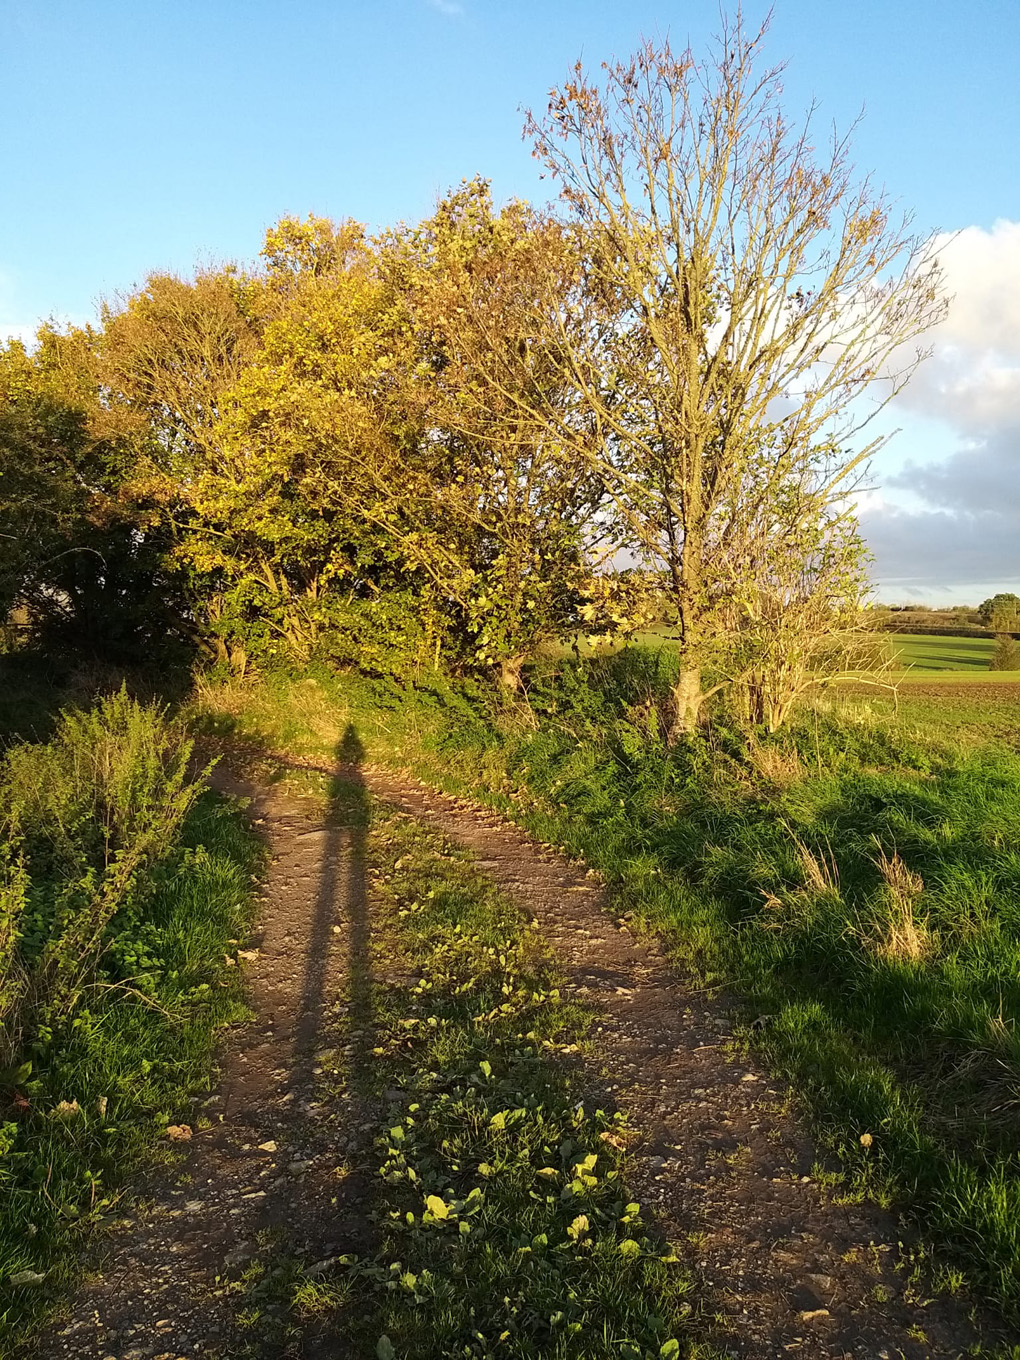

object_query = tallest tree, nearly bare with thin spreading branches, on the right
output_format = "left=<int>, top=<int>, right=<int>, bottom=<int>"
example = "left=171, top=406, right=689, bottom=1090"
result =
left=528, top=20, right=942, bottom=732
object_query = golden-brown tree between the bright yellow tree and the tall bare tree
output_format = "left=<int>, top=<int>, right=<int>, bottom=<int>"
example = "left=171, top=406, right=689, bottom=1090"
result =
left=378, top=180, right=604, bottom=691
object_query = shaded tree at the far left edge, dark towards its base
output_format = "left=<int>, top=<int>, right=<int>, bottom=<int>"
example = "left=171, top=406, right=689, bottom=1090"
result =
left=0, top=324, right=188, bottom=661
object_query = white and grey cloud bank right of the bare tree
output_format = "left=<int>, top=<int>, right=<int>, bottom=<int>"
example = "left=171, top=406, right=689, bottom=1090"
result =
left=861, top=220, right=1020, bottom=598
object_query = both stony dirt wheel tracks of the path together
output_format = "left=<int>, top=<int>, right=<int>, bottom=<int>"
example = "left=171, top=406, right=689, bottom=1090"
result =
left=33, top=768, right=1017, bottom=1360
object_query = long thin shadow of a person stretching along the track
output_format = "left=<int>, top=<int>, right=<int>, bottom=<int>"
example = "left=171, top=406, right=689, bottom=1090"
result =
left=233, top=725, right=375, bottom=1360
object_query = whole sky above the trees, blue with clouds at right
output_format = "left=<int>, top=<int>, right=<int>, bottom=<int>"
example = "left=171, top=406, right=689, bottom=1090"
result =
left=0, top=0, right=1020, bottom=598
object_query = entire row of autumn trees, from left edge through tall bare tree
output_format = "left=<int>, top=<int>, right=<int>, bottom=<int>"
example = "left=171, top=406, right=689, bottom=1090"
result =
left=0, top=13, right=944, bottom=734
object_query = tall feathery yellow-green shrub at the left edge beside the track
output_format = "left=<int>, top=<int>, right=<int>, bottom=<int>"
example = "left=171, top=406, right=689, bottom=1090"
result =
left=0, top=691, right=201, bottom=1054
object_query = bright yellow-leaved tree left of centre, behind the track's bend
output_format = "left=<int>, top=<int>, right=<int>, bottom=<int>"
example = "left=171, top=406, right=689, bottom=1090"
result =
left=212, top=218, right=439, bottom=666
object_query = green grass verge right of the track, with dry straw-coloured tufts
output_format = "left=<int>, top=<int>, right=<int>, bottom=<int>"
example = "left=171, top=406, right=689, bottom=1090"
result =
left=190, top=663, right=1020, bottom=1316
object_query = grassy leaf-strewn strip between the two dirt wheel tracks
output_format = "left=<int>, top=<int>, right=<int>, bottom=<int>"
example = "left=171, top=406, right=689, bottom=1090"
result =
left=294, top=799, right=704, bottom=1360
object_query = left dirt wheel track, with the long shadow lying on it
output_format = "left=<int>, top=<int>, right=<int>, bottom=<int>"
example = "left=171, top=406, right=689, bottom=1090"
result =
left=30, top=777, right=380, bottom=1360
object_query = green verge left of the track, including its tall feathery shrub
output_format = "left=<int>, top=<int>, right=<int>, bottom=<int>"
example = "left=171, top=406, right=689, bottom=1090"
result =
left=0, top=695, right=260, bottom=1352
